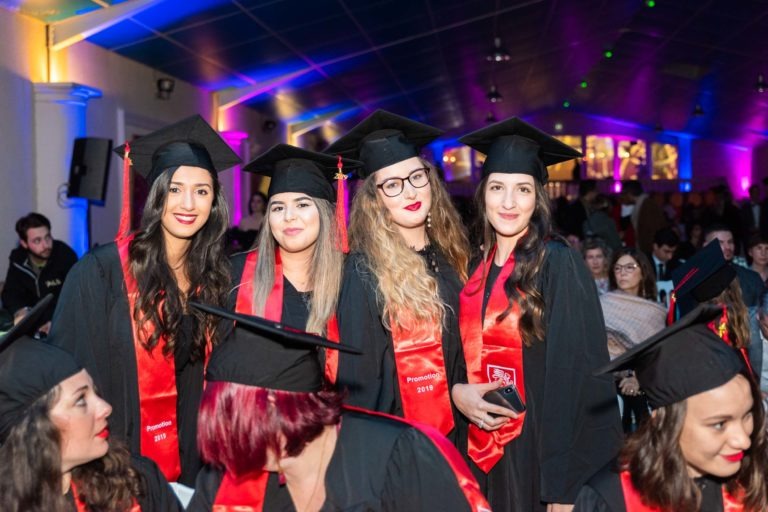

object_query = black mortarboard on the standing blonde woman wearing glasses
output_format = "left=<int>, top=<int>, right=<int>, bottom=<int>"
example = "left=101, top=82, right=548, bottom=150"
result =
left=323, top=110, right=443, bottom=178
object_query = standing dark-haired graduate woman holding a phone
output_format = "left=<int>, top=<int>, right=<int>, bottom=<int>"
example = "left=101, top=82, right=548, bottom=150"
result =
left=453, top=118, right=621, bottom=512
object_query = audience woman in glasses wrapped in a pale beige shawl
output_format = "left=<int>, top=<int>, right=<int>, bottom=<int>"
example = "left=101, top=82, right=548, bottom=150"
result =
left=600, top=247, right=666, bottom=432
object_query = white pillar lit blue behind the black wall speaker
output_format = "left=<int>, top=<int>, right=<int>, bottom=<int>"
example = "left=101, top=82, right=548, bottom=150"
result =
left=34, top=83, right=101, bottom=256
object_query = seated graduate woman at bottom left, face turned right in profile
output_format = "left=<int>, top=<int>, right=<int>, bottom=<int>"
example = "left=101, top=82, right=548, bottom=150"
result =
left=0, top=296, right=182, bottom=512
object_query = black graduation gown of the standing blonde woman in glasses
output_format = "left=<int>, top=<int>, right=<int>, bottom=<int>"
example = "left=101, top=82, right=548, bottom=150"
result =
left=337, top=251, right=467, bottom=454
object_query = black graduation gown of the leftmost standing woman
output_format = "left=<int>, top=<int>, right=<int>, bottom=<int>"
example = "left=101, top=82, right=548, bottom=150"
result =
left=50, top=243, right=204, bottom=486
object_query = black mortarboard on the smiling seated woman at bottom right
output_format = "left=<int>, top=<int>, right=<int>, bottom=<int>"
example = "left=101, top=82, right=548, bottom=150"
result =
left=595, top=305, right=745, bottom=409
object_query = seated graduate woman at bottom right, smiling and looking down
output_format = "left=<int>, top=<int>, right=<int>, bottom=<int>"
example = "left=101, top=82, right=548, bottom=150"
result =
left=574, top=306, right=768, bottom=512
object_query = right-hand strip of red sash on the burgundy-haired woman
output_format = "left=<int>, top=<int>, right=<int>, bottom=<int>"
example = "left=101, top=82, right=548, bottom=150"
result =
left=344, top=405, right=491, bottom=512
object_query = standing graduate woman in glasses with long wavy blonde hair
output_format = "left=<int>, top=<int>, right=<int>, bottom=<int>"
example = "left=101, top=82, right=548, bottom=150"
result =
left=326, top=111, right=469, bottom=448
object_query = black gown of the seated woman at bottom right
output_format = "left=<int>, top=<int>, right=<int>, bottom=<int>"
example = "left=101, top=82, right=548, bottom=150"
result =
left=573, top=465, right=724, bottom=512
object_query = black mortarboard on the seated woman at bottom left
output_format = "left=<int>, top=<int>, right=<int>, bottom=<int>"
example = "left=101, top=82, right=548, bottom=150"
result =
left=0, top=295, right=82, bottom=444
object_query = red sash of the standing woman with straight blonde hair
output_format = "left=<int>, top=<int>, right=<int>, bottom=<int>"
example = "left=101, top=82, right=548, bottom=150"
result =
left=235, top=249, right=339, bottom=384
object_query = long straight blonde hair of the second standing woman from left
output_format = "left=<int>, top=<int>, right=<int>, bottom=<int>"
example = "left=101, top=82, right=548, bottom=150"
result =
left=248, top=197, right=344, bottom=335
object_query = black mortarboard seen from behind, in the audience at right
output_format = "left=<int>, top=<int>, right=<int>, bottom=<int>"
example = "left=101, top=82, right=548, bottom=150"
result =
left=670, top=240, right=736, bottom=316
